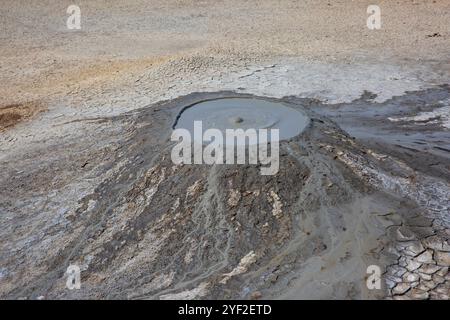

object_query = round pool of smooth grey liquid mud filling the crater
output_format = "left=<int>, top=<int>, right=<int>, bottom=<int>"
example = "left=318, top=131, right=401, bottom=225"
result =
left=174, top=98, right=309, bottom=143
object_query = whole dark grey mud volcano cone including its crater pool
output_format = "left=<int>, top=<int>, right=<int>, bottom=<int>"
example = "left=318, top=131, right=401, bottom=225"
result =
left=1, top=87, right=450, bottom=299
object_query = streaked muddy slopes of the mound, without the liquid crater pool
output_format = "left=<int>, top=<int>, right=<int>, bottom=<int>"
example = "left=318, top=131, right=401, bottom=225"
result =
left=0, top=88, right=450, bottom=299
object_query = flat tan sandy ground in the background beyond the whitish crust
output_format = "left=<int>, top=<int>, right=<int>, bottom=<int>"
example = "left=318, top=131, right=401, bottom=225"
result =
left=0, top=0, right=450, bottom=109
